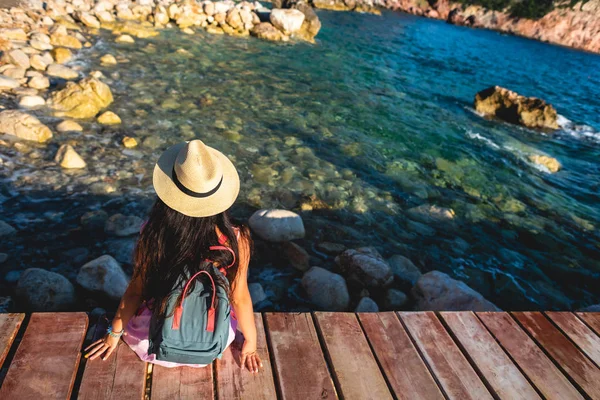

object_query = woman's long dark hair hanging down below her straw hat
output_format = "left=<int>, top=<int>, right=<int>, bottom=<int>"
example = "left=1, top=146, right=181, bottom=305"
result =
left=134, top=199, right=251, bottom=318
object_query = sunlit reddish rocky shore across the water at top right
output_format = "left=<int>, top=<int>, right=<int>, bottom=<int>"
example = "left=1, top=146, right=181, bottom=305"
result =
left=304, top=0, right=600, bottom=53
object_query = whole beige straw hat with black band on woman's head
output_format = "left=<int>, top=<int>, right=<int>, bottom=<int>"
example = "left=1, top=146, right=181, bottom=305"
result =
left=152, top=140, right=240, bottom=217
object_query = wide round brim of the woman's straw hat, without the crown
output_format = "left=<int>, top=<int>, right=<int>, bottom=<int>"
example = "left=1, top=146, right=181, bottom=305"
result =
left=152, top=142, right=240, bottom=217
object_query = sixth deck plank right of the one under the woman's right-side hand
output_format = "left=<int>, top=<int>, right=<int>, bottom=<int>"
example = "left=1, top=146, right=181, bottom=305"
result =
left=477, top=312, right=582, bottom=399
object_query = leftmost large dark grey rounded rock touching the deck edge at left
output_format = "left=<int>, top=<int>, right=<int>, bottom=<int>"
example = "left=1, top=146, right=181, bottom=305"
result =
left=15, top=268, right=75, bottom=311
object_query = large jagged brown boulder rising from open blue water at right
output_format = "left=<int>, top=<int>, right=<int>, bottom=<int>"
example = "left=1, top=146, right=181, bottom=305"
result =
left=475, top=86, right=558, bottom=129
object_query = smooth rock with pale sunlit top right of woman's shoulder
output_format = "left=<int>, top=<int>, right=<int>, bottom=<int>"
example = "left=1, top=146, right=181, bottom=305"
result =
left=248, top=209, right=305, bottom=242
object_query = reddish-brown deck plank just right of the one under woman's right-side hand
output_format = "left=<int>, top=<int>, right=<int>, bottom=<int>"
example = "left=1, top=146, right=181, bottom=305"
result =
left=265, top=313, right=337, bottom=399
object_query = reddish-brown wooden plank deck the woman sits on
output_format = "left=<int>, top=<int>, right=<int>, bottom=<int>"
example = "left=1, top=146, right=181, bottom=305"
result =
left=0, top=312, right=600, bottom=400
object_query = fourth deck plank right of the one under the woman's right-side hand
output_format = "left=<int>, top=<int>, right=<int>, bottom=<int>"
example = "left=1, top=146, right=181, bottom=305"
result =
left=398, top=312, right=492, bottom=400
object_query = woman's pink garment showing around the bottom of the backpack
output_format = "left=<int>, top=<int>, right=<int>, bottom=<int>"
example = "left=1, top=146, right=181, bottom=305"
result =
left=123, top=305, right=237, bottom=368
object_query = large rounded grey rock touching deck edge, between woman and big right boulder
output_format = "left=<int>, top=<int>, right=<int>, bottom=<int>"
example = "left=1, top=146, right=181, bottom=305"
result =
left=302, top=267, right=350, bottom=311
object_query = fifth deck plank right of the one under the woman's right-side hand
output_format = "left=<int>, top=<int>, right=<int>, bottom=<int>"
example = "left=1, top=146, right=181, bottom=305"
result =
left=440, top=312, right=540, bottom=399
